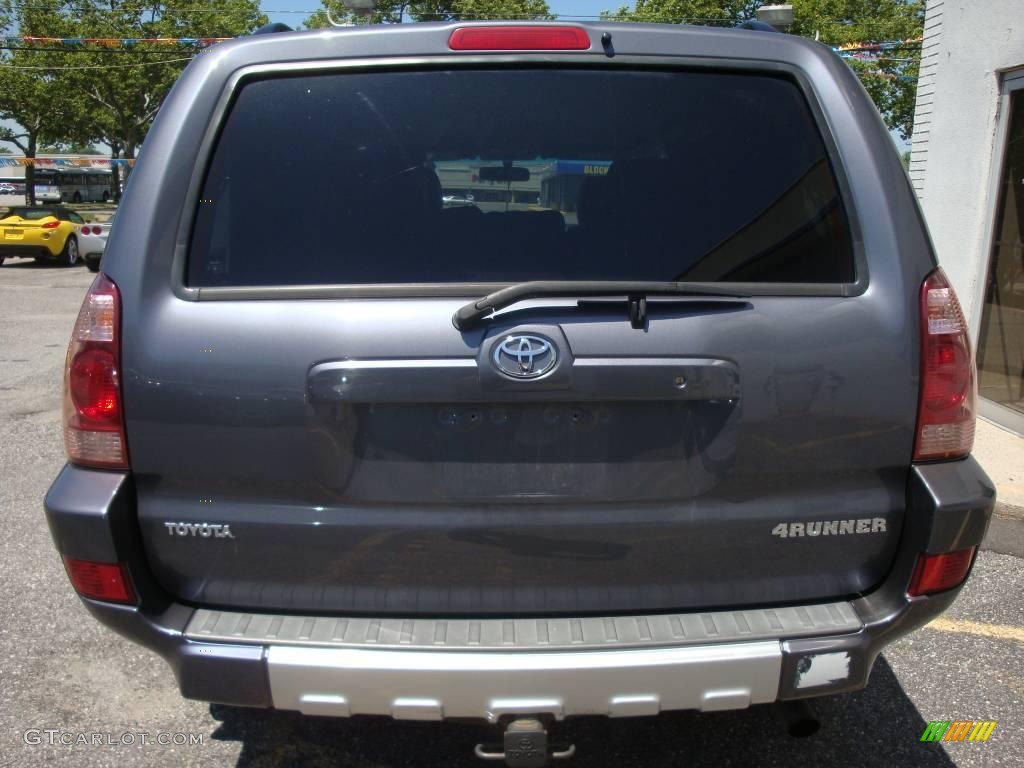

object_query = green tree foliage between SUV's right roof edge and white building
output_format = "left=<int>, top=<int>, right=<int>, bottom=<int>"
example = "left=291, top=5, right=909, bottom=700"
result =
left=602, top=0, right=925, bottom=140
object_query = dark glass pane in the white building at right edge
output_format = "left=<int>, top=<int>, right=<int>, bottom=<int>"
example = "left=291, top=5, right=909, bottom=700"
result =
left=978, top=81, right=1024, bottom=422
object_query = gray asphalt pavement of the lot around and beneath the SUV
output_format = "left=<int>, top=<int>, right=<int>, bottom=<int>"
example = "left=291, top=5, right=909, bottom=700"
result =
left=0, top=260, right=1024, bottom=768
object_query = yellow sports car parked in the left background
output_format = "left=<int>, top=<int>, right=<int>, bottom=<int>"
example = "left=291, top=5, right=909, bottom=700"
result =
left=0, top=206, right=85, bottom=266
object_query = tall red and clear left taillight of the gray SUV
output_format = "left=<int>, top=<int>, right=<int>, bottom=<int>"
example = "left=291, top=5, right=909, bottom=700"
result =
left=63, top=273, right=128, bottom=469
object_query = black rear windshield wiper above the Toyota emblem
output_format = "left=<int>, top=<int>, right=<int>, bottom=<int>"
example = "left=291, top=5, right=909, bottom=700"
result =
left=452, top=280, right=749, bottom=331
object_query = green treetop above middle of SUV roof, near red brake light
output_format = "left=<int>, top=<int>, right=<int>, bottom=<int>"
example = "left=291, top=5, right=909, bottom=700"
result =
left=305, top=0, right=554, bottom=29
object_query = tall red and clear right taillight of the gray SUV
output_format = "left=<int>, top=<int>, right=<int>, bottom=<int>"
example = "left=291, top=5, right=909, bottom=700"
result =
left=913, top=269, right=978, bottom=461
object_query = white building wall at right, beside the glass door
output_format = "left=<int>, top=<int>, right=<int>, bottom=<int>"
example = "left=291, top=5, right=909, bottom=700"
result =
left=910, top=0, right=1024, bottom=328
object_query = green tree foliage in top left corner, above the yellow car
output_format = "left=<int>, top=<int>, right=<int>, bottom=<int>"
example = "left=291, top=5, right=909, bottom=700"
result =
left=0, top=0, right=266, bottom=175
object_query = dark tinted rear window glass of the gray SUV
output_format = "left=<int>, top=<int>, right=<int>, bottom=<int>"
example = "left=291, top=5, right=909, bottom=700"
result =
left=187, top=68, right=854, bottom=287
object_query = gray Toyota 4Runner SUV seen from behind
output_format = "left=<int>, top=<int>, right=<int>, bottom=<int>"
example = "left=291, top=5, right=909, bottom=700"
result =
left=46, top=23, right=994, bottom=765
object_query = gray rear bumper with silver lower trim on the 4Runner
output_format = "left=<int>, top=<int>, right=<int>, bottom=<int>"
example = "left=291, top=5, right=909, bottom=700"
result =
left=46, top=458, right=994, bottom=721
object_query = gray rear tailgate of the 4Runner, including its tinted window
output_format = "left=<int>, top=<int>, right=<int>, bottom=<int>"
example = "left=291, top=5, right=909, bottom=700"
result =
left=124, top=36, right=918, bottom=614
